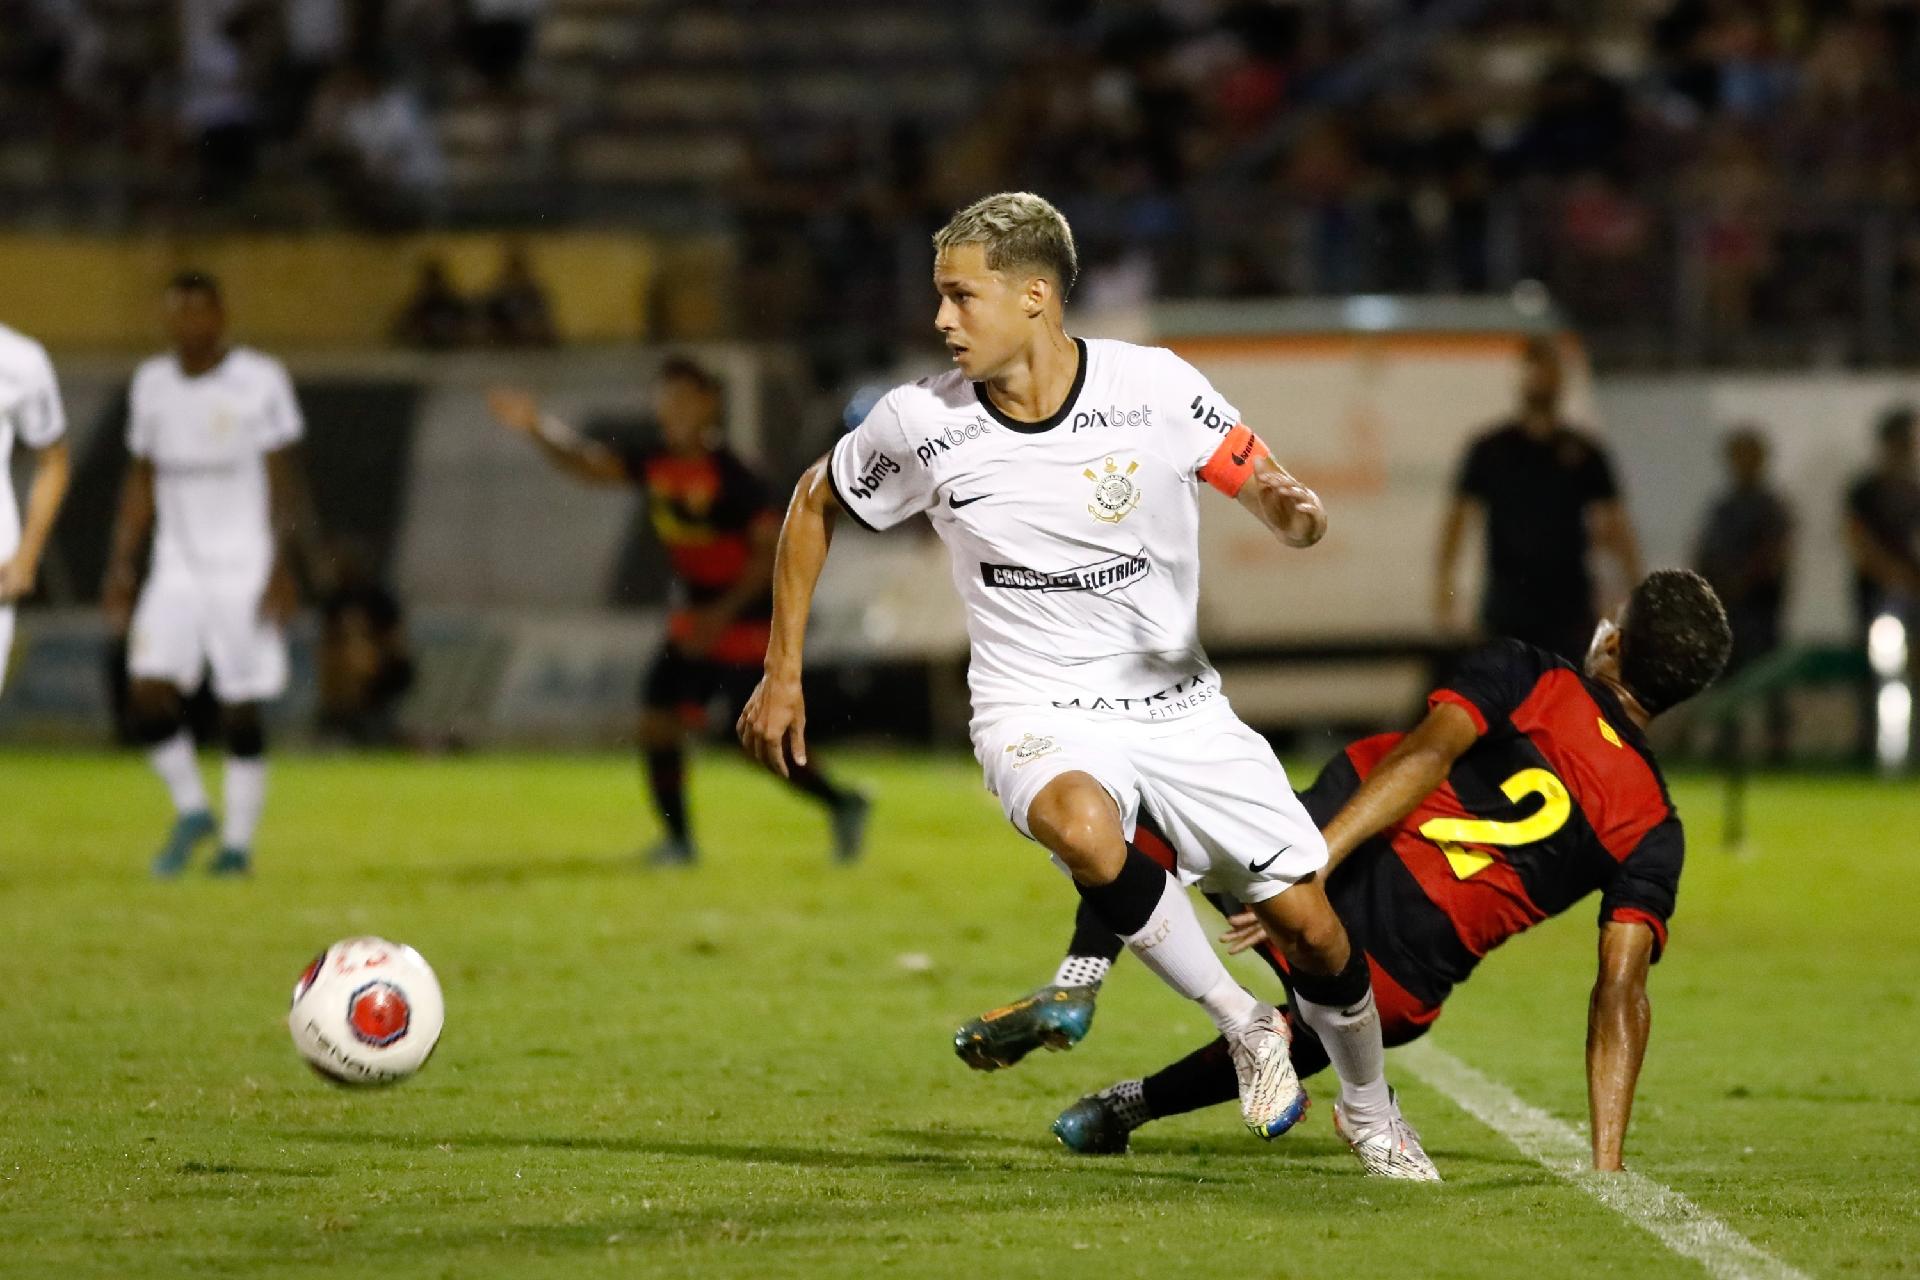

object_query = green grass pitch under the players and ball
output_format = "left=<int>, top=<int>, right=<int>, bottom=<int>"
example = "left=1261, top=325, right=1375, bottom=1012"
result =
left=0, top=754, right=1920, bottom=1280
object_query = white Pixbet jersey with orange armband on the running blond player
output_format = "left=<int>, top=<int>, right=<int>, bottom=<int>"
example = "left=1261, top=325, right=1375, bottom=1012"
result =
left=829, top=340, right=1263, bottom=720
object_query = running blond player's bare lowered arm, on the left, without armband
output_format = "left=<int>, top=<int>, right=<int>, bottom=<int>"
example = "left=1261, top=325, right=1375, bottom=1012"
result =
left=733, top=457, right=839, bottom=777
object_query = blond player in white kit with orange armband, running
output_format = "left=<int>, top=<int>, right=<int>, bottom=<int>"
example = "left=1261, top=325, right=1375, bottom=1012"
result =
left=739, top=192, right=1438, bottom=1180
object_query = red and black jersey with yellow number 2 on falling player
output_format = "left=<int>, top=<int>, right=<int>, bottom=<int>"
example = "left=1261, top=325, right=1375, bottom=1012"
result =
left=1300, top=641, right=1684, bottom=1007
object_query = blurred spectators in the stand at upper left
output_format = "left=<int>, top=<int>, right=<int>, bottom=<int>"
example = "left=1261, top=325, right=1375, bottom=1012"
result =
left=0, top=0, right=545, bottom=226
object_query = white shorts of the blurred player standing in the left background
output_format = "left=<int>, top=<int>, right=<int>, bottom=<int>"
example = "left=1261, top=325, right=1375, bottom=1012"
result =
left=127, top=578, right=286, bottom=704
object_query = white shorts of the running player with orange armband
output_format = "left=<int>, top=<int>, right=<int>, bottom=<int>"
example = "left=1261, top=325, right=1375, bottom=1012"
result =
left=973, top=699, right=1327, bottom=902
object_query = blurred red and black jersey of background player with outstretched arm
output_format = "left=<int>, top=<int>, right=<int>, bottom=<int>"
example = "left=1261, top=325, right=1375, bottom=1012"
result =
left=626, top=447, right=780, bottom=664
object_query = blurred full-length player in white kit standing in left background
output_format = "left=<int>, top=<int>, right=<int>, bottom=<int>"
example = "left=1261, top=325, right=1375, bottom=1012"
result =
left=106, top=273, right=303, bottom=877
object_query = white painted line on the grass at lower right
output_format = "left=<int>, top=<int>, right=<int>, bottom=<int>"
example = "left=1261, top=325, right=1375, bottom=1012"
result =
left=1396, top=1040, right=1809, bottom=1280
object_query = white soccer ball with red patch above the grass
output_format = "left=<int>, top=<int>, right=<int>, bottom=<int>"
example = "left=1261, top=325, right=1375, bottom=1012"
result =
left=286, top=938, right=447, bottom=1084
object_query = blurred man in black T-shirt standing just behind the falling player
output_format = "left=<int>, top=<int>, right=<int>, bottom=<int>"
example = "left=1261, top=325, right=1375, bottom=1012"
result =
left=1434, top=338, right=1640, bottom=662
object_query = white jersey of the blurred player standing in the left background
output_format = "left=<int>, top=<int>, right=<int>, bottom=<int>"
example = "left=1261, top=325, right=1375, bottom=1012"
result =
left=127, top=347, right=303, bottom=583
